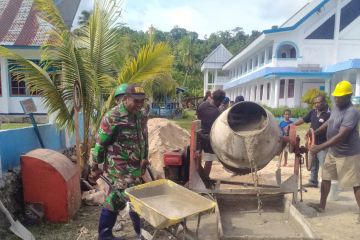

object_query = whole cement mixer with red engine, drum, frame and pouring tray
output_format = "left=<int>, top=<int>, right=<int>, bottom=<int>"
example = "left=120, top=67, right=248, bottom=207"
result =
left=159, top=102, right=319, bottom=240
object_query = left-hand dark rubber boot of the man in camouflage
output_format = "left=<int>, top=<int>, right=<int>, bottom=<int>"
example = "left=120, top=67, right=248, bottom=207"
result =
left=98, top=208, right=124, bottom=240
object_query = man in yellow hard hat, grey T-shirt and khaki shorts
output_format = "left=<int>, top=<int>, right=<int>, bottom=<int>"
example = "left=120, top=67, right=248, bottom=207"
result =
left=310, top=81, right=360, bottom=220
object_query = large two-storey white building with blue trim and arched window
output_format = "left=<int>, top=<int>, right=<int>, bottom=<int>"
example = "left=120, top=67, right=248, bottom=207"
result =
left=202, top=0, right=360, bottom=107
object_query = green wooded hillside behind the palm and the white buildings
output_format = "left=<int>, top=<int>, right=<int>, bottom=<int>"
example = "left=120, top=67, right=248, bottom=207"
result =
left=116, top=26, right=260, bottom=97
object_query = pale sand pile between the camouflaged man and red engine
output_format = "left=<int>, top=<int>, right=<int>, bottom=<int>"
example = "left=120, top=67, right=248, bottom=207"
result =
left=148, top=118, right=190, bottom=177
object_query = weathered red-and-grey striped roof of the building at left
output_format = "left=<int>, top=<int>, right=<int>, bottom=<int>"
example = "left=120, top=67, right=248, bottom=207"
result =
left=0, top=0, right=51, bottom=46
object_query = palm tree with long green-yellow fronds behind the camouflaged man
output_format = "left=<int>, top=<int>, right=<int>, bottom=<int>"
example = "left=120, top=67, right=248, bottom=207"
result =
left=0, top=0, right=173, bottom=168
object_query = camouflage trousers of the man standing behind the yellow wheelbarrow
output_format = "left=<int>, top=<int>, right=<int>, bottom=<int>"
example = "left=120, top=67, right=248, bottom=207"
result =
left=104, top=173, right=143, bottom=212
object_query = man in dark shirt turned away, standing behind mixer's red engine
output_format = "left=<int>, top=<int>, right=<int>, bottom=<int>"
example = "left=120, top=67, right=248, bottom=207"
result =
left=197, top=90, right=225, bottom=177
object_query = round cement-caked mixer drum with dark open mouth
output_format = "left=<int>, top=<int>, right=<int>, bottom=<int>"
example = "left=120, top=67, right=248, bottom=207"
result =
left=210, top=102, right=284, bottom=174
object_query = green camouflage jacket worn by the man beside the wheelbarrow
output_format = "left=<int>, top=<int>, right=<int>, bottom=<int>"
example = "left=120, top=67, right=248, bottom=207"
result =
left=92, top=103, right=148, bottom=177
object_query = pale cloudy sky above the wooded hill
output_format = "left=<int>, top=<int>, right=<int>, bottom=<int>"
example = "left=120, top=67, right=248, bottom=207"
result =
left=79, top=0, right=311, bottom=39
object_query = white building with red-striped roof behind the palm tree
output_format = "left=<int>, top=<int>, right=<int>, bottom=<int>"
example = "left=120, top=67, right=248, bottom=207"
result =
left=0, top=0, right=80, bottom=115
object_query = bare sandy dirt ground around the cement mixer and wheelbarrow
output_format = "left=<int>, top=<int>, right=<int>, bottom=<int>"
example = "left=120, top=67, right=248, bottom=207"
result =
left=0, top=131, right=360, bottom=240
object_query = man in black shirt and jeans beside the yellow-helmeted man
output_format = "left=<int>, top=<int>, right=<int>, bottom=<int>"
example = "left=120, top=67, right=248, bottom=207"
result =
left=295, top=95, right=330, bottom=187
